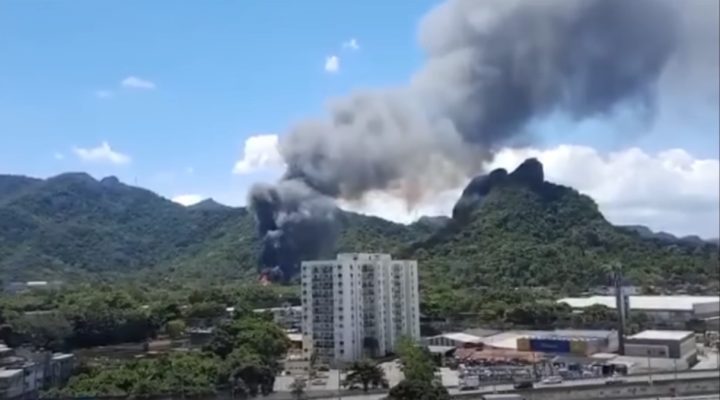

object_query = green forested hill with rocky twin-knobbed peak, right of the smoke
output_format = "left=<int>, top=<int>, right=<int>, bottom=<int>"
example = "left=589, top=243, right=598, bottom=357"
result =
left=405, top=159, right=718, bottom=300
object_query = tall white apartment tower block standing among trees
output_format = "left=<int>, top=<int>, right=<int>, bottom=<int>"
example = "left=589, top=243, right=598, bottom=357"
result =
left=301, top=253, right=420, bottom=365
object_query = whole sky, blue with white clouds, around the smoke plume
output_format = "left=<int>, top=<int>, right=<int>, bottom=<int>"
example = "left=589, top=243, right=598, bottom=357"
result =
left=0, top=0, right=720, bottom=237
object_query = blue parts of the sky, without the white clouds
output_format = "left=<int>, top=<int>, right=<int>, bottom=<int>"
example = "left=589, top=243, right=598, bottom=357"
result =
left=0, top=0, right=718, bottom=236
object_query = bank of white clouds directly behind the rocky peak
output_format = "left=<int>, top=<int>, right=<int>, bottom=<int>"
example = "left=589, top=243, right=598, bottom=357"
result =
left=342, top=145, right=720, bottom=237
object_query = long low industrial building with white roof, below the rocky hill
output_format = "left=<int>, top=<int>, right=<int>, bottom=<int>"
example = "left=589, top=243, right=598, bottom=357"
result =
left=558, top=296, right=720, bottom=325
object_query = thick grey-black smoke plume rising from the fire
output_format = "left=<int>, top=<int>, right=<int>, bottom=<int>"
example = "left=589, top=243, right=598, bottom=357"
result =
left=250, top=0, right=712, bottom=278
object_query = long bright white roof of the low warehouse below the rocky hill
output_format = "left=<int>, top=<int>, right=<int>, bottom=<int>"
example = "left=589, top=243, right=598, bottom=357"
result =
left=558, top=296, right=720, bottom=311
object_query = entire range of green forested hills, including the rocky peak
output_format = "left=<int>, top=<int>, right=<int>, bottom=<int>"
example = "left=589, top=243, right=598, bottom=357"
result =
left=0, top=161, right=718, bottom=292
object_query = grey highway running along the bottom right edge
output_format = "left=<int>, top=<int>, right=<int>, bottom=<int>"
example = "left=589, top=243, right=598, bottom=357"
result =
left=328, top=370, right=720, bottom=400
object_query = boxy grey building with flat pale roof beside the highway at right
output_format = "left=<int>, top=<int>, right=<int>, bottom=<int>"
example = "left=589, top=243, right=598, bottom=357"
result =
left=625, top=330, right=697, bottom=364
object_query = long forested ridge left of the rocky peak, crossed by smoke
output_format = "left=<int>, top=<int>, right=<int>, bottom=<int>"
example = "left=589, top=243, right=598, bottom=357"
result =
left=0, top=173, right=414, bottom=281
